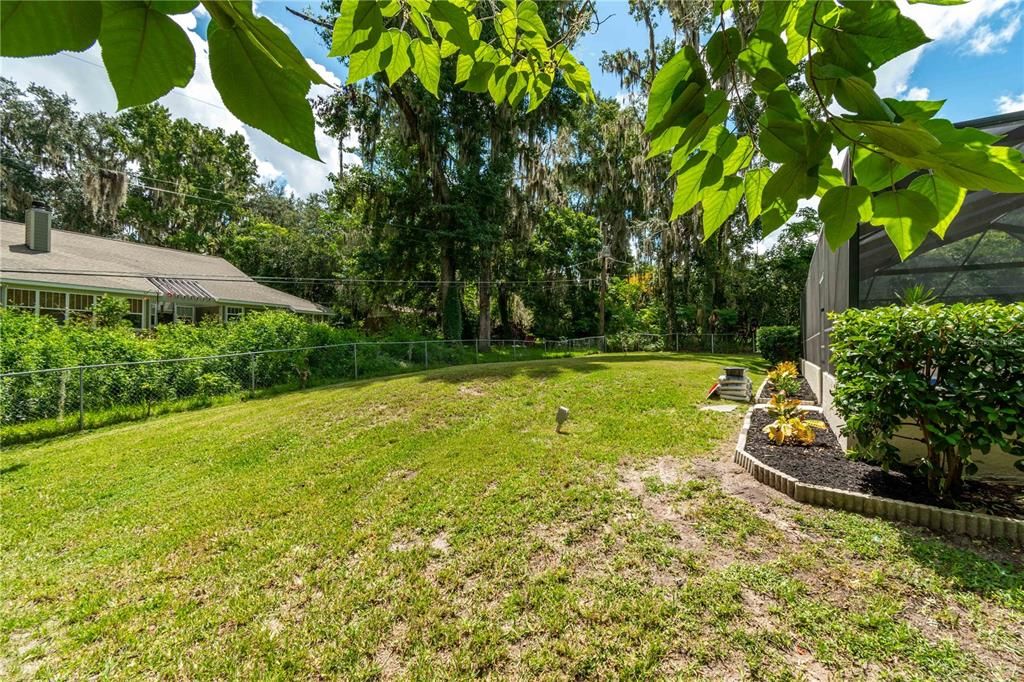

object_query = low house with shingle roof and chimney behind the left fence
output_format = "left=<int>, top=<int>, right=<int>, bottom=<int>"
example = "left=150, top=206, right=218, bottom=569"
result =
left=0, top=208, right=329, bottom=329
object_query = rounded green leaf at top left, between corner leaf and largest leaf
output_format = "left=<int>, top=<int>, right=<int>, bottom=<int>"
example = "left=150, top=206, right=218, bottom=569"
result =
left=99, top=2, right=196, bottom=109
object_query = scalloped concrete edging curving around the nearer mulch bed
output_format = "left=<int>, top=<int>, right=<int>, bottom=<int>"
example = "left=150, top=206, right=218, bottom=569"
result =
left=732, top=404, right=1024, bottom=545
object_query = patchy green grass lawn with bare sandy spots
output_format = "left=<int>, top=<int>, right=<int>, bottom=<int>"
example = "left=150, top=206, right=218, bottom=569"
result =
left=0, top=354, right=1024, bottom=680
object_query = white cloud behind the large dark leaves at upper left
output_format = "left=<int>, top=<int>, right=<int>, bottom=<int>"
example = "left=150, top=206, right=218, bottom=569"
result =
left=0, top=5, right=350, bottom=196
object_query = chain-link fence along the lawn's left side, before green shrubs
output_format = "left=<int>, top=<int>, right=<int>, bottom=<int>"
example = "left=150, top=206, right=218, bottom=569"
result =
left=0, top=337, right=605, bottom=443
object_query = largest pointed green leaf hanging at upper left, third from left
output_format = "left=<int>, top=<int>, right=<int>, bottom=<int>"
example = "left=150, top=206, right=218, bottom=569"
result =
left=207, top=22, right=319, bottom=160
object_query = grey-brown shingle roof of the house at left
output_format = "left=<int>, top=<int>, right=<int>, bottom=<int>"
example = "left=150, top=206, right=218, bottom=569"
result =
left=0, top=220, right=324, bottom=312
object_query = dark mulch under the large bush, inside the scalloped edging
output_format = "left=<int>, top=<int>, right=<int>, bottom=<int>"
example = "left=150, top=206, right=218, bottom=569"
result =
left=746, top=410, right=1024, bottom=518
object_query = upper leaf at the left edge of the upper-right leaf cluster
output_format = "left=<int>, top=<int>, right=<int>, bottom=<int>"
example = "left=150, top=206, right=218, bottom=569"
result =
left=644, top=45, right=708, bottom=137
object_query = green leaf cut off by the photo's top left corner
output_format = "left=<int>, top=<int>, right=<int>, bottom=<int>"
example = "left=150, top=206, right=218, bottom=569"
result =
left=0, top=0, right=102, bottom=56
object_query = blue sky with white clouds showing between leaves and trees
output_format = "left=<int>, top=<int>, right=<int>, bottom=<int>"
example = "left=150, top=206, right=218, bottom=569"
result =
left=0, top=0, right=1024, bottom=196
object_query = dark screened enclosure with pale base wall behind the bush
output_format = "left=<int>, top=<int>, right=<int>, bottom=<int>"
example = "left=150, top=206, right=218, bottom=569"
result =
left=801, top=112, right=1024, bottom=473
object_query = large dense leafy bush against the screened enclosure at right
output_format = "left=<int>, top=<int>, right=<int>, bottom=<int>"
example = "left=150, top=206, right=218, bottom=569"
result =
left=831, top=302, right=1024, bottom=497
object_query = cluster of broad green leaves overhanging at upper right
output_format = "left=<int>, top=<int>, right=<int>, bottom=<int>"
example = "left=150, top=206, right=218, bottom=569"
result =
left=645, top=0, right=1024, bottom=258
